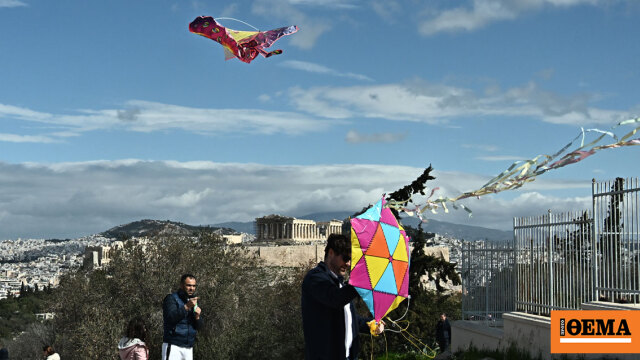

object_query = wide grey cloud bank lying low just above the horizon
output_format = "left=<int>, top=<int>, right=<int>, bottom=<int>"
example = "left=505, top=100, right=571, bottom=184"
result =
left=0, top=159, right=590, bottom=239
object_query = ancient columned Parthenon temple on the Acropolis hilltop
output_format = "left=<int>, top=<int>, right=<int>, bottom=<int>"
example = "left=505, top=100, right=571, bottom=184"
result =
left=256, top=214, right=342, bottom=243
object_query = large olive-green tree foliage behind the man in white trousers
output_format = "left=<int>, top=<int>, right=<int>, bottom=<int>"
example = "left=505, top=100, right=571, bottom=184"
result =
left=26, top=233, right=304, bottom=359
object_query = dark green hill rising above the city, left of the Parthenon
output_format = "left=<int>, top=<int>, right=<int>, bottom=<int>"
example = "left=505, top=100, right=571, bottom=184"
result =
left=99, top=219, right=236, bottom=239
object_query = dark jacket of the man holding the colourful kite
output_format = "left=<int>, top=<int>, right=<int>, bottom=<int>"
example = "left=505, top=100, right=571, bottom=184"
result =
left=302, top=262, right=369, bottom=360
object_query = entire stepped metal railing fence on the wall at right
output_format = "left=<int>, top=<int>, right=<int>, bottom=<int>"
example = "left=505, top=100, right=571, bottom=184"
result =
left=461, top=178, right=640, bottom=320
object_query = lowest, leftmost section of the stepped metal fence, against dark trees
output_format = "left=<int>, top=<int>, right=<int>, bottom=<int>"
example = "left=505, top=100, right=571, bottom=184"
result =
left=461, top=242, right=515, bottom=326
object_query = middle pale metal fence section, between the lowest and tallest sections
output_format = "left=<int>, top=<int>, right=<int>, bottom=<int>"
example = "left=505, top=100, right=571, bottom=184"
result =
left=513, top=211, right=594, bottom=315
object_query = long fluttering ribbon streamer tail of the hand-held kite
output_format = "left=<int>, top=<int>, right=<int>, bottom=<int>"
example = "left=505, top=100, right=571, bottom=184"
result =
left=388, top=117, right=640, bottom=221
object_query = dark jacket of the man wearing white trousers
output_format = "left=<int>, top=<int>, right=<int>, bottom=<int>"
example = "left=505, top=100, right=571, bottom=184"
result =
left=162, top=289, right=202, bottom=348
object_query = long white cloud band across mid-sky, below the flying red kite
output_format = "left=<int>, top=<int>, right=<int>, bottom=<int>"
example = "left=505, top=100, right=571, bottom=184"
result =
left=0, top=80, right=633, bottom=143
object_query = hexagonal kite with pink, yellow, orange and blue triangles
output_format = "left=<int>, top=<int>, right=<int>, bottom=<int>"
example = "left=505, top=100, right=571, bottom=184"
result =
left=349, top=198, right=409, bottom=322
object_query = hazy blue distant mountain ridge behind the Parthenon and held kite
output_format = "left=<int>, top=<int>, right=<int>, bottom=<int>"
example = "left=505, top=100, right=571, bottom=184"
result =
left=212, top=211, right=513, bottom=241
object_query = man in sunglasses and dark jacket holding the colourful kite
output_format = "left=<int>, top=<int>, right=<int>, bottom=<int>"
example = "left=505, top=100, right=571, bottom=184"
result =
left=302, top=234, right=384, bottom=360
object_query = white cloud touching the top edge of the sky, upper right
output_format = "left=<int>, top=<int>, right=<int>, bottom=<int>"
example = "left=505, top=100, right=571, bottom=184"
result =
left=418, top=0, right=599, bottom=35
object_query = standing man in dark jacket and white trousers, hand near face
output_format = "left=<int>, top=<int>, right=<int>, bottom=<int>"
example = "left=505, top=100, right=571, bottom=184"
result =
left=162, top=274, right=202, bottom=360
